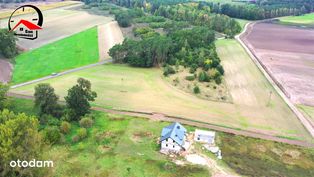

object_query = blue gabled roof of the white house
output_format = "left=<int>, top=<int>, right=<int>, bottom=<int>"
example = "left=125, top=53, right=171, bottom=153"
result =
left=160, top=122, right=186, bottom=146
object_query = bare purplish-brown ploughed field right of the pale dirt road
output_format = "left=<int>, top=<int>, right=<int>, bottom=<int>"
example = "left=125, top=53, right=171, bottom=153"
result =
left=242, top=22, right=314, bottom=106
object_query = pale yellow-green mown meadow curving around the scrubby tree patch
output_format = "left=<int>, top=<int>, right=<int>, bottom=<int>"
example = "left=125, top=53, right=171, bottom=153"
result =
left=11, top=47, right=311, bottom=140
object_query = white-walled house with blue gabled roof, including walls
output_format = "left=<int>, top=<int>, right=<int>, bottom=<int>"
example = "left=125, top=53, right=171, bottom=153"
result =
left=160, top=122, right=187, bottom=153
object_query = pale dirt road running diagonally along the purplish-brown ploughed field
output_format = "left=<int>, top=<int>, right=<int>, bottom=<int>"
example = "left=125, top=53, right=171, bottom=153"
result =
left=235, top=21, right=314, bottom=138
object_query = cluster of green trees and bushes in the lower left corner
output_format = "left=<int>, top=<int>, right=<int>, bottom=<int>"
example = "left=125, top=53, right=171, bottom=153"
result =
left=0, top=78, right=97, bottom=177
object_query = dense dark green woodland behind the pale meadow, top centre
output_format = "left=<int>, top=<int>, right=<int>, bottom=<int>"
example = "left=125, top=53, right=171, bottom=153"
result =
left=109, top=0, right=228, bottom=84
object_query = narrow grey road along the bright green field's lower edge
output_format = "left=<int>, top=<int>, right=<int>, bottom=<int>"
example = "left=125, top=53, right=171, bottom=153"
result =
left=10, top=59, right=112, bottom=89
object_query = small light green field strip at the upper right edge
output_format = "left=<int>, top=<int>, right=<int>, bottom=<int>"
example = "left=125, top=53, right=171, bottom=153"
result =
left=279, top=13, right=314, bottom=26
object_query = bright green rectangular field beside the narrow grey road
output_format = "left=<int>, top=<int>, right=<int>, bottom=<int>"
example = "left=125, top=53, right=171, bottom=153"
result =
left=12, top=27, right=99, bottom=84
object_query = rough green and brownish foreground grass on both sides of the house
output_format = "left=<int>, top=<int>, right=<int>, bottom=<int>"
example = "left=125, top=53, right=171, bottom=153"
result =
left=8, top=99, right=314, bottom=177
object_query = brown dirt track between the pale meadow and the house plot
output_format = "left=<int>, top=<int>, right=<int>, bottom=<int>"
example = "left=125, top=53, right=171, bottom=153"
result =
left=7, top=92, right=314, bottom=148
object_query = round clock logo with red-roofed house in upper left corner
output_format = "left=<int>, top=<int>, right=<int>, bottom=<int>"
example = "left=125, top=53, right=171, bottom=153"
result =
left=8, top=5, right=43, bottom=40
